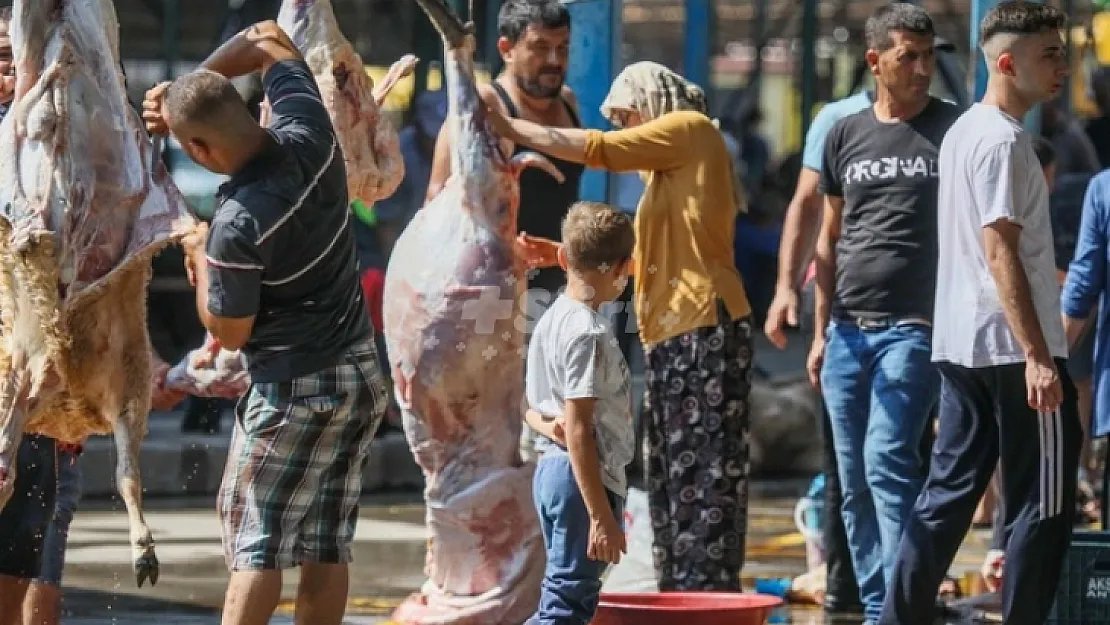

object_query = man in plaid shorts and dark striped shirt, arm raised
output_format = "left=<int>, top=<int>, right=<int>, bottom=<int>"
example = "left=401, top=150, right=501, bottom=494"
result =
left=143, top=21, right=386, bottom=625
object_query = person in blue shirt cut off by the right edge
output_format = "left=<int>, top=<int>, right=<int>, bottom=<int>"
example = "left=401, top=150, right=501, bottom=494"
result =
left=1060, top=170, right=1110, bottom=528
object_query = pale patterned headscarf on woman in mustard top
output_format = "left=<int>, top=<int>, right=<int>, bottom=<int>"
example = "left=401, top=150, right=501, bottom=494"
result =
left=602, top=61, right=707, bottom=122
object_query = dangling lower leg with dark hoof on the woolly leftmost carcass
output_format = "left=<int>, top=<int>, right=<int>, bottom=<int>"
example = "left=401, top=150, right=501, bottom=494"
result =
left=112, top=410, right=158, bottom=587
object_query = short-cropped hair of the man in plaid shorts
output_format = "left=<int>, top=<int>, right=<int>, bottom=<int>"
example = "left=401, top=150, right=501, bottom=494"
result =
left=165, top=70, right=251, bottom=130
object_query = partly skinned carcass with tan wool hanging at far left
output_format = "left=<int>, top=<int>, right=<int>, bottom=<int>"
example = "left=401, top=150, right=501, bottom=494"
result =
left=0, top=0, right=194, bottom=586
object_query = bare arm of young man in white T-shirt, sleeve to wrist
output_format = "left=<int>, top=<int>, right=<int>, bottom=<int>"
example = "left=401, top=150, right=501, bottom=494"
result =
left=982, top=220, right=1052, bottom=362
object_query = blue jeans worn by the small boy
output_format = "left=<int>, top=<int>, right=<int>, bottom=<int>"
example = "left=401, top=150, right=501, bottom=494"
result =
left=527, top=451, right=624, bottom=625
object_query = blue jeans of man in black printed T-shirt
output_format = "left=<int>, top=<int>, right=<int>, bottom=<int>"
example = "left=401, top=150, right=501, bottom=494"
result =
left=821, top=321, right=940, bottom=621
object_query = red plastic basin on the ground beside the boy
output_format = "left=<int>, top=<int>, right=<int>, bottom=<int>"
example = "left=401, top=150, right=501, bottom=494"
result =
left=591, top=593, right=783, bottom=625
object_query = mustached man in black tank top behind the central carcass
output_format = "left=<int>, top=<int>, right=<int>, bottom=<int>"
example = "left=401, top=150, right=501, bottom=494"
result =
left=427, top=0, right=583, bottom=317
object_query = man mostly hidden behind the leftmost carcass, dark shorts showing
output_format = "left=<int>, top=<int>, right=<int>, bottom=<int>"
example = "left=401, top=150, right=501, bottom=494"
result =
left=0, top=7, right=58, bottom=625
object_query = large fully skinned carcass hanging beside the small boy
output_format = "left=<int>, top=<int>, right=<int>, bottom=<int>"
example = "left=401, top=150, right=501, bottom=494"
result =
left=383, top=0, right=563, bottom=624
